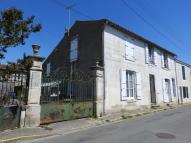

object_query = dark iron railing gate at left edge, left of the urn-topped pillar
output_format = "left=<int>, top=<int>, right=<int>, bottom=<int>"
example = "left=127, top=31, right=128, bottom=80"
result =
left=0, top=69, right=28, bottom=130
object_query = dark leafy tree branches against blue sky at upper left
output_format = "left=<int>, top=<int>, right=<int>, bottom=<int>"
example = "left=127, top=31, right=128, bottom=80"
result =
left=0, top=8, right=42, bottom=59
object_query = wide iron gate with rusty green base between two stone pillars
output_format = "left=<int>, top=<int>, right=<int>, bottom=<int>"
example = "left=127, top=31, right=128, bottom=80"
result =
left=41, top=78, right=94, bottom=124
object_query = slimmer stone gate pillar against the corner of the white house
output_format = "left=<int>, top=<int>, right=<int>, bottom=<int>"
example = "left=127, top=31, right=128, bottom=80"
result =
left=91, top=62, right=105, bottom=117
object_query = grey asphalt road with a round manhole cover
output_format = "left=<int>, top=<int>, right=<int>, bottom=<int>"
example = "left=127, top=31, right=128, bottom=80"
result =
left=24, top=107, right=191, bottom=143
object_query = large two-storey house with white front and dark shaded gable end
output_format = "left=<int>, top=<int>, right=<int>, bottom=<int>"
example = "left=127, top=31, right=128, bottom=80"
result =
left=43, top=19, right=190, bottom=114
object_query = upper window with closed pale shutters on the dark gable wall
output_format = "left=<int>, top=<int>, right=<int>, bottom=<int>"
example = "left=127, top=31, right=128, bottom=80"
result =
left=70, top=38, right=78, bottom=62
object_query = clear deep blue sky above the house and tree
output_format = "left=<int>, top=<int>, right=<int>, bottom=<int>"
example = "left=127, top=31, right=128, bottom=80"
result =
left=0, top=0, right=191, bottom=64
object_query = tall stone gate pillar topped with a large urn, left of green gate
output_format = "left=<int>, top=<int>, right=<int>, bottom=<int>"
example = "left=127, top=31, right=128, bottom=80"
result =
left=25, top=45, right=44, bottom=127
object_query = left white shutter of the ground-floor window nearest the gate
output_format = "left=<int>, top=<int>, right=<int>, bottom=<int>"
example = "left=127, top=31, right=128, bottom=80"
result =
left=121, top=70, right=127, bottom=101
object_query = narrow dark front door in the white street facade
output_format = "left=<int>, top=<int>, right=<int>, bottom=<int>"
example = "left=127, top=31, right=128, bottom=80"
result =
left=149, top=74, right=156, bottom=104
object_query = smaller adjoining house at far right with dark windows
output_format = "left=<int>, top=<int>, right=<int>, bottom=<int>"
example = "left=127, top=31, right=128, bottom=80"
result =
left=176, top=60, right=191, bottom=103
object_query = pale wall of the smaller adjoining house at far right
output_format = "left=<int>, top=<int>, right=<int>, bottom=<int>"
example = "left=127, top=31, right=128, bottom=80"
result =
left=176, top=61, right=191, bottom=103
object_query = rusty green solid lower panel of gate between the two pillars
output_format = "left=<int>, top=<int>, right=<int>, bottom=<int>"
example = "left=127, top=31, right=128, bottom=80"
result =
left=40, top=101, right=93, bottom=124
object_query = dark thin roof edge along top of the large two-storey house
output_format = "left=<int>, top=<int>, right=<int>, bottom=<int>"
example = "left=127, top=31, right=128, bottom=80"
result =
left=77, top=19, right=176, bottom=56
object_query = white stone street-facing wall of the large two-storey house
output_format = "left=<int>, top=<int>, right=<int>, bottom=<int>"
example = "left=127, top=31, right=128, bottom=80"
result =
left=104, top=26, right=176, bottom=113
